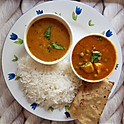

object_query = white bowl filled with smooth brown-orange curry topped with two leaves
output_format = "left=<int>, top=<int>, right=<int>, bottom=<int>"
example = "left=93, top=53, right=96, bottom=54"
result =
left=24, top=13, right=73, bottom=65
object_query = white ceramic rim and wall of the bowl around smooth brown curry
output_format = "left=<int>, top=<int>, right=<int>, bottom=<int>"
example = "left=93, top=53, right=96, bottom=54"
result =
left=24, top=13, right=73, bottom=65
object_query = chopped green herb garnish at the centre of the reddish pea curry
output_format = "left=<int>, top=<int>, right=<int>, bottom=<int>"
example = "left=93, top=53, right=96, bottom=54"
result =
left=91, top=51, right=102, bottom=63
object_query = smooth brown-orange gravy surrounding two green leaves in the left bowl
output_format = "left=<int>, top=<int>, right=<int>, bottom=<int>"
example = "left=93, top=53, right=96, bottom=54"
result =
left=27, top=18, right=70, bottom=62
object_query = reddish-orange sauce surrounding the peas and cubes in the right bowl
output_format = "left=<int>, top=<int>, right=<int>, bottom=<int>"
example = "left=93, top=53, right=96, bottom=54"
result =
left=72, top=35, right=117, bottom=80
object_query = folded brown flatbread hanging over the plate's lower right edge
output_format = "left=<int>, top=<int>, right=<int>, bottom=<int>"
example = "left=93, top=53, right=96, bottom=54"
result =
left=69, top=79, right=114, bottom=124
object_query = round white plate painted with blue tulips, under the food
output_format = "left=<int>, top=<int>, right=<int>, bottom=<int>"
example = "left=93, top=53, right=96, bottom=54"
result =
left=2, top=1, right=122, bottom=121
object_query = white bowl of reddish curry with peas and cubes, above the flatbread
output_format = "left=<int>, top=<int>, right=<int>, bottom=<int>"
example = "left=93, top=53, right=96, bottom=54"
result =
left=70, top=34, right=117, bottom=82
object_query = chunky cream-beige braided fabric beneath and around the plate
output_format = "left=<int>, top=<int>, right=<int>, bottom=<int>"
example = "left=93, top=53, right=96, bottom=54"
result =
left=0, top=0, right=124, bottom=124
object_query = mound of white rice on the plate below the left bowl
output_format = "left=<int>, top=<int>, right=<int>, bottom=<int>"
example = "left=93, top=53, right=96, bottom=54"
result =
left=17, top=56, right=81, bottom=109
